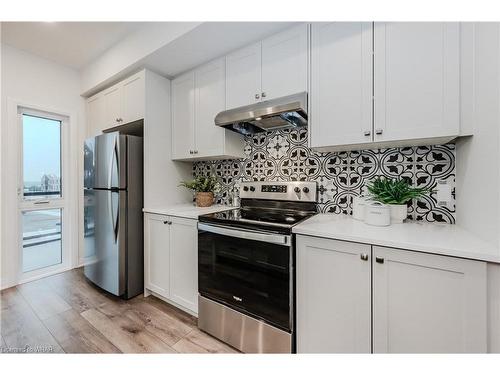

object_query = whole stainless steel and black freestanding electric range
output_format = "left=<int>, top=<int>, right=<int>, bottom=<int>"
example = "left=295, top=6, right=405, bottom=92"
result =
left=198, top=182, right=317, bottom=353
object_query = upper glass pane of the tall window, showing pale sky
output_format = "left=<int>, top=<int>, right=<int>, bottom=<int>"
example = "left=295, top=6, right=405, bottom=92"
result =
left=23, top=114, right=61, bottom=199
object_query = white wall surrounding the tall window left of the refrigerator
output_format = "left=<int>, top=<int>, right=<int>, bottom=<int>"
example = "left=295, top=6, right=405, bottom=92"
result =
left=0, top=44, right=86, bottom=288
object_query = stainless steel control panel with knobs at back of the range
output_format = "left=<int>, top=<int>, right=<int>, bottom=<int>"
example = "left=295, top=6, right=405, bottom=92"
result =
left=240, top=181, right=317, bottom=202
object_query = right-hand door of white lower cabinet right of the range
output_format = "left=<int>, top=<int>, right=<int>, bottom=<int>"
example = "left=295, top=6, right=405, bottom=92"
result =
left=373, top=246, right=487, bottom=353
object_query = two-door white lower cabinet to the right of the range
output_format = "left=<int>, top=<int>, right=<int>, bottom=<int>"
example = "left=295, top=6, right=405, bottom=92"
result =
left=297, top=236, right=487, bottom=353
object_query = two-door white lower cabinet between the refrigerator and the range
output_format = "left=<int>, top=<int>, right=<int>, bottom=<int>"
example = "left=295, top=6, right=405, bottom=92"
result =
left=144, top=214, right=198, bottom=314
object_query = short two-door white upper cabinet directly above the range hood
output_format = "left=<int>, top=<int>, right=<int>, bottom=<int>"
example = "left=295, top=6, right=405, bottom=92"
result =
left=226, top=24, right=308, bottom=109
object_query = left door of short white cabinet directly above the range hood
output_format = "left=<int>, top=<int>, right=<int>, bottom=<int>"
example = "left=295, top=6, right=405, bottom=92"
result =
left=226, top=42, right=262, bottom=109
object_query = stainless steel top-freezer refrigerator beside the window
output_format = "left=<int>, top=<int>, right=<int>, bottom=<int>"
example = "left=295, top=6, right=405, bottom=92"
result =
left=84, top=132, right=144, bottom=298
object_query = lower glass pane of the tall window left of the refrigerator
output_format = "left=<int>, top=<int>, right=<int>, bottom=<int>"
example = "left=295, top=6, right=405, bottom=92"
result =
left=23, top=209, right=62, bottom=272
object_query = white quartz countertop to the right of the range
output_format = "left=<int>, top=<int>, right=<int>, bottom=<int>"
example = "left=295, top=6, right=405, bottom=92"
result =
left=293, top=214, right=500, bottom=263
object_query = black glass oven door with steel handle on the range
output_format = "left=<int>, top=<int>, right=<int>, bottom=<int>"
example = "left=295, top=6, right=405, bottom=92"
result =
left=198, top=223, right=293, bottom=332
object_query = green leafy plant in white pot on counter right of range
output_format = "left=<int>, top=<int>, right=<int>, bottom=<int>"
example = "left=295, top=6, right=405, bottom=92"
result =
left=366, top=177, right=430, bottom=223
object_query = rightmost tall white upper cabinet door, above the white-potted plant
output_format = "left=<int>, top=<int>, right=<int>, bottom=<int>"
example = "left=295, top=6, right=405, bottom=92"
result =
left=374, top=22, right=460, bottom=142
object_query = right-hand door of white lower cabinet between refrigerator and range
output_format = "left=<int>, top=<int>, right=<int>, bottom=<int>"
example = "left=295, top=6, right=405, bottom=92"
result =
left=170, top=217, right=198, bottom=313
